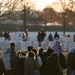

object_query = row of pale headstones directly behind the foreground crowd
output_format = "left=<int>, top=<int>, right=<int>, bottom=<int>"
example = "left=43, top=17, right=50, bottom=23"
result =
left=0, top=41, right=75, bottom=52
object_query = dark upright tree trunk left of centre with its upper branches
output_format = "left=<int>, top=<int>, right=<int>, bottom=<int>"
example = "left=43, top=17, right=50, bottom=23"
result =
left=21, top=0, right=35, bottom=30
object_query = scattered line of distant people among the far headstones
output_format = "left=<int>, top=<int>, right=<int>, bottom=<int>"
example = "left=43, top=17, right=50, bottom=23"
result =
left=0, top=29, right=72, bottom=42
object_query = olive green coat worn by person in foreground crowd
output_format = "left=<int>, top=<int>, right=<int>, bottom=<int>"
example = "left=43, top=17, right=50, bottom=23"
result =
left=24, top=57, right=39, bottom=75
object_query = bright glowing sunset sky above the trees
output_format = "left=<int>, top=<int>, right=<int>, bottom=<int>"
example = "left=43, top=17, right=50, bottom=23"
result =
left=0, top=0, right=69, bottom=12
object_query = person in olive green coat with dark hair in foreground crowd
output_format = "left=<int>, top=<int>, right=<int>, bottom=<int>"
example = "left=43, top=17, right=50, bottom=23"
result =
left=24, top=51, right=40, bottom=75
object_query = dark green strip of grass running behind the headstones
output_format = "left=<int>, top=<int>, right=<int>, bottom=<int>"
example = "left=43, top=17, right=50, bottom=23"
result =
left=0, top=24, right=75, bottom=31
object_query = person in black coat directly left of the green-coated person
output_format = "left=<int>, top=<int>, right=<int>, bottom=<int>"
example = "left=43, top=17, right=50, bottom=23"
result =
left=15, top=52, right=26, bottom=75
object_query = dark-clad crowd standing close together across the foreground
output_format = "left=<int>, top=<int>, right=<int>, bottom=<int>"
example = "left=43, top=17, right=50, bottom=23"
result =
left=0, top=41, right=75, bottom=75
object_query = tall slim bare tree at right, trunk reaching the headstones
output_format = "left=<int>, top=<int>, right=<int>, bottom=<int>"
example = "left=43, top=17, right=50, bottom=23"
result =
left=60, top=0, right=74, bottom=35
